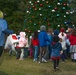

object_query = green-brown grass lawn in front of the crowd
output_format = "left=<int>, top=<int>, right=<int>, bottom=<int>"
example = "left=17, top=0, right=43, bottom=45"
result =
left=0, top=53, right=76, bottom=75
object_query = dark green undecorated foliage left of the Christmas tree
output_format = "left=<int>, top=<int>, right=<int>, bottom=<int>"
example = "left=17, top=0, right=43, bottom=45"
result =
left=0, top=0, right=26, bottom=33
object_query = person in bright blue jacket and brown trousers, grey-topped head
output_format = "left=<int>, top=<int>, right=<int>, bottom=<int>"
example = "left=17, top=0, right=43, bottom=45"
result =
left=38, top=25, right=50, bottom=63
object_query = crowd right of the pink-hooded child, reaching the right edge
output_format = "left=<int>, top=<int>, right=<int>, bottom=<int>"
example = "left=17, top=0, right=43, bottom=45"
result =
left=28, top=25, right=76, bottom=70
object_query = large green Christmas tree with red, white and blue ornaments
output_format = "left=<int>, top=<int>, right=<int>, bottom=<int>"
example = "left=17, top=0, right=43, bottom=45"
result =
left=23, top=0, right=74, bottom=33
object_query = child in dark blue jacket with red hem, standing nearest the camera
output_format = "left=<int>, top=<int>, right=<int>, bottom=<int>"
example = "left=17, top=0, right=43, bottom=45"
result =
left=51, top=35, right=62, bottom=71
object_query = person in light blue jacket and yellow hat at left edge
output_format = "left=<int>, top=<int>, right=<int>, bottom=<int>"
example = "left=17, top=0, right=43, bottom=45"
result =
left=0, top=11, right=14, bottom=57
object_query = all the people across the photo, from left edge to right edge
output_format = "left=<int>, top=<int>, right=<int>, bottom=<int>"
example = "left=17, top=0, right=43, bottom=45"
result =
left=0, top=11, right=76, bottom=71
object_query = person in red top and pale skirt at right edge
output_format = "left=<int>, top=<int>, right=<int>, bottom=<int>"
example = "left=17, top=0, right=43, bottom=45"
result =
left=69, top=28, right=76, bottom=61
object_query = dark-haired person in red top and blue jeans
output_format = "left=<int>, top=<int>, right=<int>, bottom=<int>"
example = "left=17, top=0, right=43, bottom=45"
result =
left=32, top=31, right=39, bottom=61
